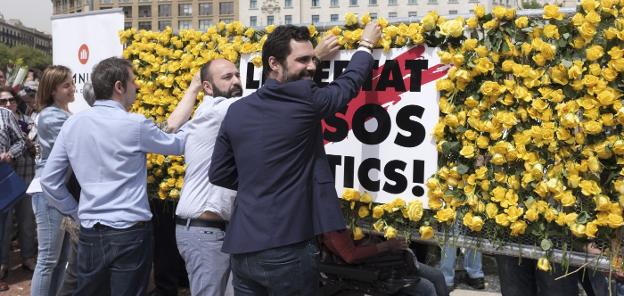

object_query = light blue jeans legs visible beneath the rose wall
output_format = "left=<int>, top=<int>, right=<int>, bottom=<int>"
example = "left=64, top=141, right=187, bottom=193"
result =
left=440, top=244, right=483, bottom=287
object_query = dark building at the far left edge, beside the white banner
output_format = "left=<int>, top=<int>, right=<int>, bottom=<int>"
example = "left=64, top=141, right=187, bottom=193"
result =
left=0, top=14, right=52, bottom=55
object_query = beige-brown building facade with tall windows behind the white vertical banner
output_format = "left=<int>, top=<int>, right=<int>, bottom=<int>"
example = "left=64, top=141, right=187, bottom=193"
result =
left=52, top=0, right=239, bottom=31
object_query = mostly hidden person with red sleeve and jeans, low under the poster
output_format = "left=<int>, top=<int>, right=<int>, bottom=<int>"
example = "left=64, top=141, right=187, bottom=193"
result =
left=322, top=230, right=449, bottom=296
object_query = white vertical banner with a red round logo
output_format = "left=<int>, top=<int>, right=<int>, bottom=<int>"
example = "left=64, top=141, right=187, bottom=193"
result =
left=52, top=8, right=124, bottom=113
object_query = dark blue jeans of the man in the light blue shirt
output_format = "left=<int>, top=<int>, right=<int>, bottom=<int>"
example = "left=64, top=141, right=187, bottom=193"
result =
left=74, top=222, right=154, bottom=296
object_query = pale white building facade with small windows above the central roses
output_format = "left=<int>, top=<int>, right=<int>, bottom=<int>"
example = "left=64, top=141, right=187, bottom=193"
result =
left=239, top=0, right=492, bottom=26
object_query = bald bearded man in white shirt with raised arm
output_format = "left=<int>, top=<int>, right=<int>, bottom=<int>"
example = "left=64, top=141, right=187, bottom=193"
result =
left=167, top=59, right=243, bottom=295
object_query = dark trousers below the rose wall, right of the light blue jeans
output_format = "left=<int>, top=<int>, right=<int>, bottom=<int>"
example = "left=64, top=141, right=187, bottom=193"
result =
left=496, top=256, right=578, bottom=296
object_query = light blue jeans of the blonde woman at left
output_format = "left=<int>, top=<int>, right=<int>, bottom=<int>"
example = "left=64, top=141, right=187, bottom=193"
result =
left=30, top=193, right=70, bottom=296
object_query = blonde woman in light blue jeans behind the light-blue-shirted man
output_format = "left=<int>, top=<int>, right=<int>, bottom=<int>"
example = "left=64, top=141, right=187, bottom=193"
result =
left=31, top=66, right=76, bottom=296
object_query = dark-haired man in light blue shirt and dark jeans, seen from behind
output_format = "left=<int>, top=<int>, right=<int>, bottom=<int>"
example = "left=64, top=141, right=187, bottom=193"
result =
left=41, top=57, right=186, bottom=295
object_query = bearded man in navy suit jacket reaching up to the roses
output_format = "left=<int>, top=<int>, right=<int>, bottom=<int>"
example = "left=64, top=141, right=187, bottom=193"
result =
left=209, top=24, right=381, bottom=295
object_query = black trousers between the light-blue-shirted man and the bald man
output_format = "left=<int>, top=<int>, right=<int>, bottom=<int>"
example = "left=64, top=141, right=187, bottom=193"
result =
left=150, top=199, right=188, bottom=296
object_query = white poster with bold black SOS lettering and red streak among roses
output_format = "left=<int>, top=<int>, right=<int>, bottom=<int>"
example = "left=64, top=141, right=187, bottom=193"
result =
left=240, top=46, right=446, bottom=206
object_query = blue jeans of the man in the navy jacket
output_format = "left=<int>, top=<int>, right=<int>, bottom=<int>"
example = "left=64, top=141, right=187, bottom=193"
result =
left=231, top=240, right=319, bottom=296
